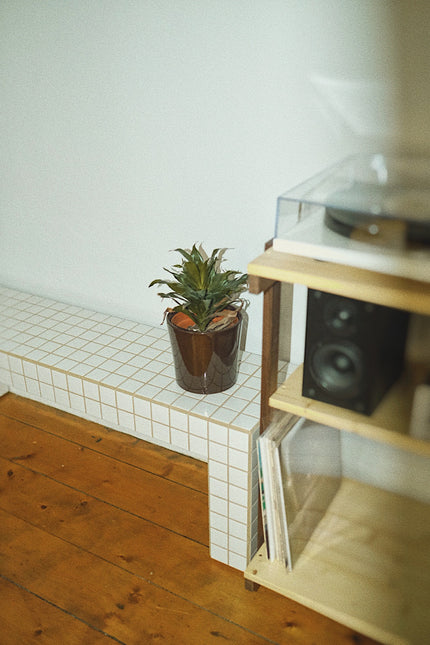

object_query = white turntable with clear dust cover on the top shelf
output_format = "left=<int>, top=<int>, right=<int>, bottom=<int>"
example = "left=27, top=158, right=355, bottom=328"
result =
left=273, top=154, right=430, bottom=282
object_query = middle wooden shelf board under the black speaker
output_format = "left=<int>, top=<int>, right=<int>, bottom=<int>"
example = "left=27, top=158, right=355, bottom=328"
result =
left=269, top=365, right=430, bottom=456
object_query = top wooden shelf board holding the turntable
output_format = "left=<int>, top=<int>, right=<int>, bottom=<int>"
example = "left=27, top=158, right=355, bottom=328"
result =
left=248, top=248, right=430, bottom=315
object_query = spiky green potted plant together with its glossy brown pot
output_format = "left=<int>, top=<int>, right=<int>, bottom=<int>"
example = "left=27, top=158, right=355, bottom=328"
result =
left=149, top=244, right=248, bottom=394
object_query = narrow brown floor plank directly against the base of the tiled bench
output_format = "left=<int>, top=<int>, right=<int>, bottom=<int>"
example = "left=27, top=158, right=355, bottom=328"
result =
left=0, top=392, right=208, bottom=493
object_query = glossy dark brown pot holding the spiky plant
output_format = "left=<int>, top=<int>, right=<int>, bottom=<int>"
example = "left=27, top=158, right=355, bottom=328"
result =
left=167, top=312, right=242, bottom=394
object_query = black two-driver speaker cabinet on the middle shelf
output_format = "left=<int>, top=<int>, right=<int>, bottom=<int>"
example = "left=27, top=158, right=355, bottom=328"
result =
left=302, top=289, right=409, bottom=415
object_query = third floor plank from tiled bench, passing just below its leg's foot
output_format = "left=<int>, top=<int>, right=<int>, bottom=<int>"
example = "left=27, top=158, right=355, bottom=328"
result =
left=0, top=459, right=372, bottom=645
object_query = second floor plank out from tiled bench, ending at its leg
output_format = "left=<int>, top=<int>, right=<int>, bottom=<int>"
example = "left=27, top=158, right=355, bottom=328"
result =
left=0, top=416, right=209, bottom=545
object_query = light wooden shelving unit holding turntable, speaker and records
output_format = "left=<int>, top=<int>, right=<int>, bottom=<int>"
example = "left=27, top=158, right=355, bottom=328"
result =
left=245, top=249, right=430, bottom=645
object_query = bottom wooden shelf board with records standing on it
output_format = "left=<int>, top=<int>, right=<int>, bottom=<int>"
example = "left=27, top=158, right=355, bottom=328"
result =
left=245, top=479, right=430, bottom=645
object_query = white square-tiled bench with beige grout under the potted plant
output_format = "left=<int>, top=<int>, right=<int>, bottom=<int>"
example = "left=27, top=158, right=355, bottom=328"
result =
left=0, top=286, right=268, bottom=570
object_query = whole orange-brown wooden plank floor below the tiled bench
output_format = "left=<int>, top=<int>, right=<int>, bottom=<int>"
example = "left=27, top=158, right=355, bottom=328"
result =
left=0, top=394, right=374, bottom=645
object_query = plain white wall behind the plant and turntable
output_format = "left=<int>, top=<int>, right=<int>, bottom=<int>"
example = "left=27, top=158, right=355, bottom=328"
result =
left=0, top=0, right=430, bottom=351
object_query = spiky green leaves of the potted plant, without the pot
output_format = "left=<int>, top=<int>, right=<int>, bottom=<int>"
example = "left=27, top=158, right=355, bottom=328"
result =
left=149, top=244, right=248, bottom=331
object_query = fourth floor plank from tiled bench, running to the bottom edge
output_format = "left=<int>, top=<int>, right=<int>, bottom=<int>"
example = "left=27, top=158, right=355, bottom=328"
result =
left=0, top=511, right=267, bottom=645
